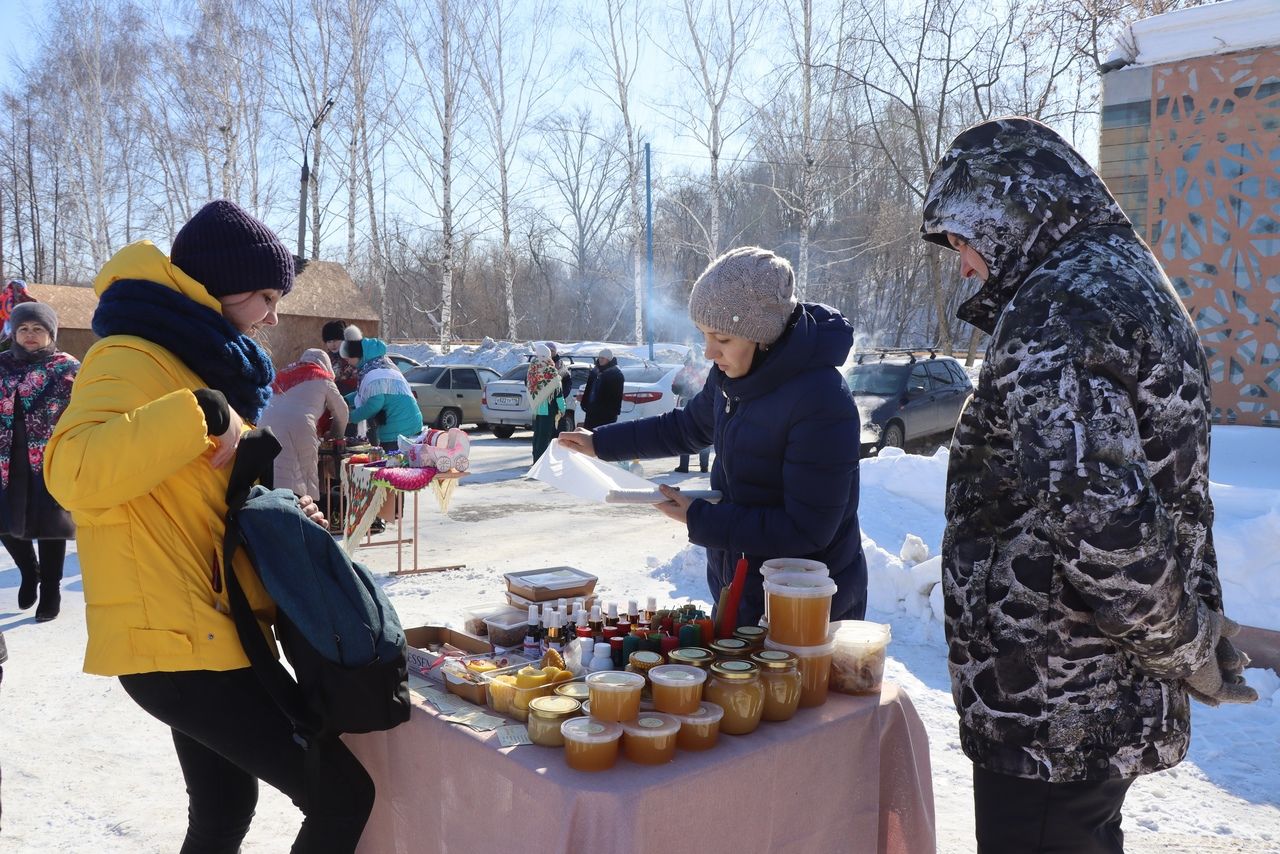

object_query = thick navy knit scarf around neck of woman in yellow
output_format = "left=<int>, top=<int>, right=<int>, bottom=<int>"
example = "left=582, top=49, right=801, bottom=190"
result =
left=93, top=279, right=275, bottom=424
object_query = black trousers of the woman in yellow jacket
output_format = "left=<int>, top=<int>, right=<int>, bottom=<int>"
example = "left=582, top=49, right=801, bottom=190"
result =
left=120, top=668, right=374, bottom=854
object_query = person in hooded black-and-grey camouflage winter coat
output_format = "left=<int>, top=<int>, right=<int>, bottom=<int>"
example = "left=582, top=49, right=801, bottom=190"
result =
left=922, top=118, right=1257, bottom=853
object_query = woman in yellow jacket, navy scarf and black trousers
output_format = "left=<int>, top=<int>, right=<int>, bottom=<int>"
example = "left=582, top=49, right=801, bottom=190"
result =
left=45, top=200, right=374, bottom=854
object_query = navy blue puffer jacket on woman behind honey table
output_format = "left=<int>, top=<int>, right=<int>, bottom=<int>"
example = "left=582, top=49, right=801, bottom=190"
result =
left=594, top=303, right=867, bottom=625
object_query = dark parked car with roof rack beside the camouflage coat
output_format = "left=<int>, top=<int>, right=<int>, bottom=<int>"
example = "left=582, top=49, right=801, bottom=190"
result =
left=845, top=350, right=973, bottom=456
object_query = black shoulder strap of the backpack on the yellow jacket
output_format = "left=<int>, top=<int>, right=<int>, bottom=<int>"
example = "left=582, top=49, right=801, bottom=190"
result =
left=223, top=428, right=319, bottom=746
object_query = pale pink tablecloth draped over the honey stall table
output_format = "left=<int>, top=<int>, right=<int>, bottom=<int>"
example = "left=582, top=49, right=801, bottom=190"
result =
left=346, top=684, right=936, bottom=854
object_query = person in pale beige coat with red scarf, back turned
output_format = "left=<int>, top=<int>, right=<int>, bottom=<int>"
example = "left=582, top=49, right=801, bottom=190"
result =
left=259, top=350, right=347, bottom=495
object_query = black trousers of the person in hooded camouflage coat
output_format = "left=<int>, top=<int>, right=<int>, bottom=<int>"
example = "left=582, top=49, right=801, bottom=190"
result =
left=973, top=766, right=1133, bottom=854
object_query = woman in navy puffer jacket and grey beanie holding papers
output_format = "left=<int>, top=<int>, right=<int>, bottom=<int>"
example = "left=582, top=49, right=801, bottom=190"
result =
left=561, top=246, right=867, bottom=626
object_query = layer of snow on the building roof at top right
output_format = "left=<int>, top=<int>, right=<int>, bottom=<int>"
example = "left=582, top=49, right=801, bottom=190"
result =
left=1103, top=0, right=1280, bottom=70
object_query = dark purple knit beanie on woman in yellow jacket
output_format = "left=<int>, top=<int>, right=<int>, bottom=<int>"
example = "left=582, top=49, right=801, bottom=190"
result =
left=169, top=198, right=294, bottom=297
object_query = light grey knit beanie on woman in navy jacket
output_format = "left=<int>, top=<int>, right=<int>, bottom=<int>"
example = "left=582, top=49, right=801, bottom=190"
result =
left=689, top=246, right=796, bottom=344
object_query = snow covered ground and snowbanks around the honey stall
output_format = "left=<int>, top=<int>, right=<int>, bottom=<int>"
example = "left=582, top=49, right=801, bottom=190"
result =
left=0, top=428, right=1280, bottom=854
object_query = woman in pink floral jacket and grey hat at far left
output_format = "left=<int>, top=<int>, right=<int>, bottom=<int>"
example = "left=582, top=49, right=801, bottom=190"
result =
left=0, top=302, right=79, bottom=622
